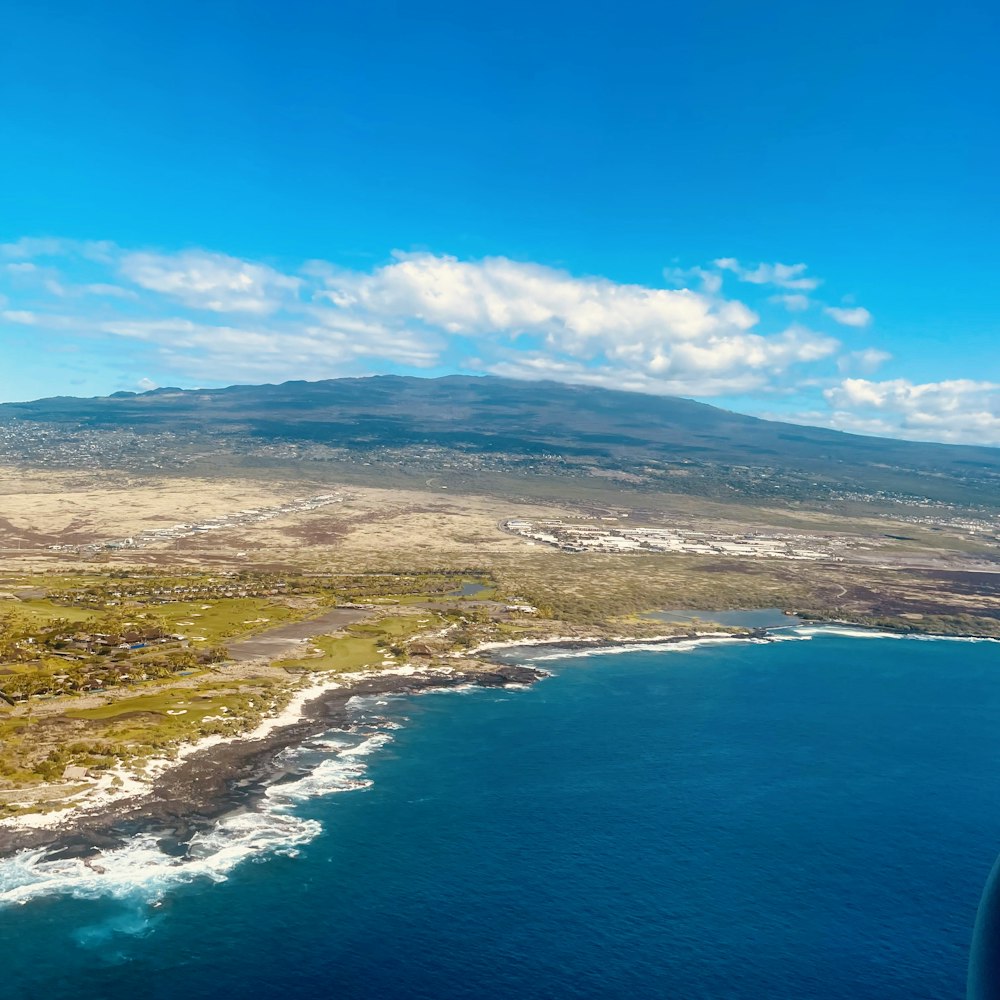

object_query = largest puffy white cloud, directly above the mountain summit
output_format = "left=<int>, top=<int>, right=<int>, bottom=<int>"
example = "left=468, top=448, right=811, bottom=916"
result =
left=308, top=253, right=839, bottom=394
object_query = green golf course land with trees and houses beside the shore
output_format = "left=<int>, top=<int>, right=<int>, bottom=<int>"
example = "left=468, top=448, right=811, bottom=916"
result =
left=0, top=571, right=536, bottom=814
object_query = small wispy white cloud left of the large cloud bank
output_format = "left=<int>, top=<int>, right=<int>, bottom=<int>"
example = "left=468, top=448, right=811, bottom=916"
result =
left=119, top=250, right=302, bottom=315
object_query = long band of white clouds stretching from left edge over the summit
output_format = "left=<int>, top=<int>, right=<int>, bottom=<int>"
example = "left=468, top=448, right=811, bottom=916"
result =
left=0, top=240, right=916, bottom=418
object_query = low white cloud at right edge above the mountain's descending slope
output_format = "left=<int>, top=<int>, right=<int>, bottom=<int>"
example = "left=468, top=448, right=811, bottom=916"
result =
left=824, top=378, right=1000, bottom=445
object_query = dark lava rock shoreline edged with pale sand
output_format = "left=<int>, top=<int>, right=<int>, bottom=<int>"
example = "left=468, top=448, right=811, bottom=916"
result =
left=0, top=621, right=1000, bottom=867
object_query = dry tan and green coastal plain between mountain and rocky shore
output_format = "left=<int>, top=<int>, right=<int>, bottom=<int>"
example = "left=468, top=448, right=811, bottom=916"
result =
left=0, top=424, right=1000, bottom=828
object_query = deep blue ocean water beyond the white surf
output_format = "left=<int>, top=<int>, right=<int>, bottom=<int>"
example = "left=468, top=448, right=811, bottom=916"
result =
left=0, top=635, right=1000, bottom=1000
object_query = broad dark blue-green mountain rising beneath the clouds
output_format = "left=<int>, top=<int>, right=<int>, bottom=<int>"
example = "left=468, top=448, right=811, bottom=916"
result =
left=0, top=375, right=1000, bottom=501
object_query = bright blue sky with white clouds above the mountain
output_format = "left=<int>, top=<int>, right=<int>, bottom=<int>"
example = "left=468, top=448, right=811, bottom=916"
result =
left=0, top=0, right=1000, bottom=444
